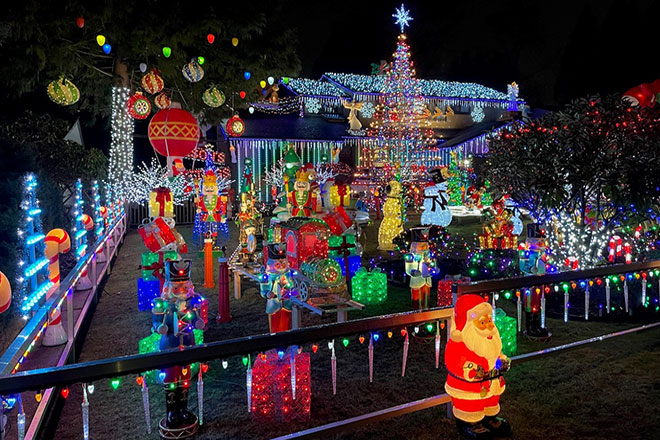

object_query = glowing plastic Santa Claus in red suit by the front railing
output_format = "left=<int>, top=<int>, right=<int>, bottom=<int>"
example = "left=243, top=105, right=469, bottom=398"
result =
left=445, top=294, right=511, bottom=439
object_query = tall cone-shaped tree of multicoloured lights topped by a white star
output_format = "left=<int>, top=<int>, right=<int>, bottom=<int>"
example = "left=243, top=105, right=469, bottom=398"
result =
left=368, top=6, right=435, bottom=167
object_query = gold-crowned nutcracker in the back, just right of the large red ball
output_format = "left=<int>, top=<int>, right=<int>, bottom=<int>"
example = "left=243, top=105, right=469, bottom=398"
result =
left=195, top=170, right=229, bottom=248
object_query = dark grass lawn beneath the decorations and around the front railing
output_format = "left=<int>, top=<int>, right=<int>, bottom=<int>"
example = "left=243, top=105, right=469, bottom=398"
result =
left=12, top=220, right=660, bottom=440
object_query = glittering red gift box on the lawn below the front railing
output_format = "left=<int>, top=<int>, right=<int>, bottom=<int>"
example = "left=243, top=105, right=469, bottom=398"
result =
left=250, top=347, right=312, bottom=423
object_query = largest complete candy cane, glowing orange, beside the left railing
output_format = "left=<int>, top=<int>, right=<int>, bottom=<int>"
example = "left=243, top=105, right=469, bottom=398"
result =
left=42, top=228, right=71, bottom=347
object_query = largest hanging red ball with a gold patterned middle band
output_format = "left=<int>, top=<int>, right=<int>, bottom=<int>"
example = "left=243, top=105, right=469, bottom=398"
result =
left=148, top=108, right=199, bottom=157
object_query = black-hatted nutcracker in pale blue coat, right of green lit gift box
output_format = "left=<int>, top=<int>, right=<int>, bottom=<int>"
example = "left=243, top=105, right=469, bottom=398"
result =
left=404, top=227, right=435, bottom=309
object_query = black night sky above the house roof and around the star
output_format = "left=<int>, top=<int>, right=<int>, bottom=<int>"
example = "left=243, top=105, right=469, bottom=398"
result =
left=286, top=0, right=660, bottom=108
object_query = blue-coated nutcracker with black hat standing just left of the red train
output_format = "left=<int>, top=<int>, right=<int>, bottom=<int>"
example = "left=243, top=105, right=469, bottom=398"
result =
left=261, top=243, right=298, bottom=333
